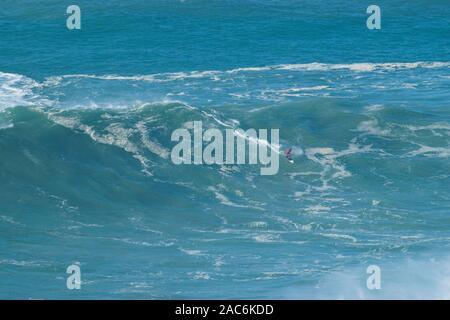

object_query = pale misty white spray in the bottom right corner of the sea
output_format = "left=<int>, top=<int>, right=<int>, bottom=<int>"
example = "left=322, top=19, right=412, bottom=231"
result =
left=283, top=252, right=450, bottom=300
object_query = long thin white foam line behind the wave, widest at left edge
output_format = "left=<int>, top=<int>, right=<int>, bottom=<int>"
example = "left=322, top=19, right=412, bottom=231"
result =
left=0, top=61, right=450, bottom=109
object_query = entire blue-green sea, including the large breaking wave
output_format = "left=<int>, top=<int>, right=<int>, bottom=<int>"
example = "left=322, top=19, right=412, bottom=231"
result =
left=0, top=0, right=450, bottom=299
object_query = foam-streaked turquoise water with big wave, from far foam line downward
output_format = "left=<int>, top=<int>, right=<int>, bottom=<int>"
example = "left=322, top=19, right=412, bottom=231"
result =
left=0, top=62, right=450, bottom=298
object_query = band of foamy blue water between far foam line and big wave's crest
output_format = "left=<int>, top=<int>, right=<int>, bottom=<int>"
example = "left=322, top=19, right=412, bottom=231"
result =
left=0, top=61, right=450, bottom=110
